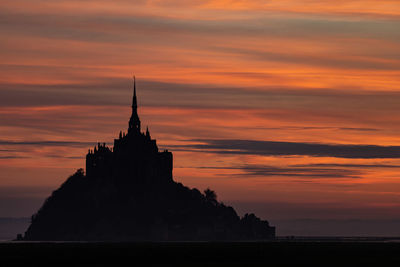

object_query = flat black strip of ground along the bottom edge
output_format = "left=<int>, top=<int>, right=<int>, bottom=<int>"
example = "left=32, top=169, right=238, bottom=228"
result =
left=0, top=242, right=400, bottom=266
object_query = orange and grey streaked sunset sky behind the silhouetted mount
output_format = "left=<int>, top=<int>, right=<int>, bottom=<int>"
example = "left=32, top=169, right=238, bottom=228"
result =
left=0, top=0, right=400, bottom=235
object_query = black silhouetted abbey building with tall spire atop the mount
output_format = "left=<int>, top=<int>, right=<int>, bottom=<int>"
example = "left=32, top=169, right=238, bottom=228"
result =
left=86, top=77, right=173, bottom=184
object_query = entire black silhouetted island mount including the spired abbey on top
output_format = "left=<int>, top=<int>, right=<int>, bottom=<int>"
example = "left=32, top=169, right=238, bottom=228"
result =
left=23, top=78, right=275, bottom=241
